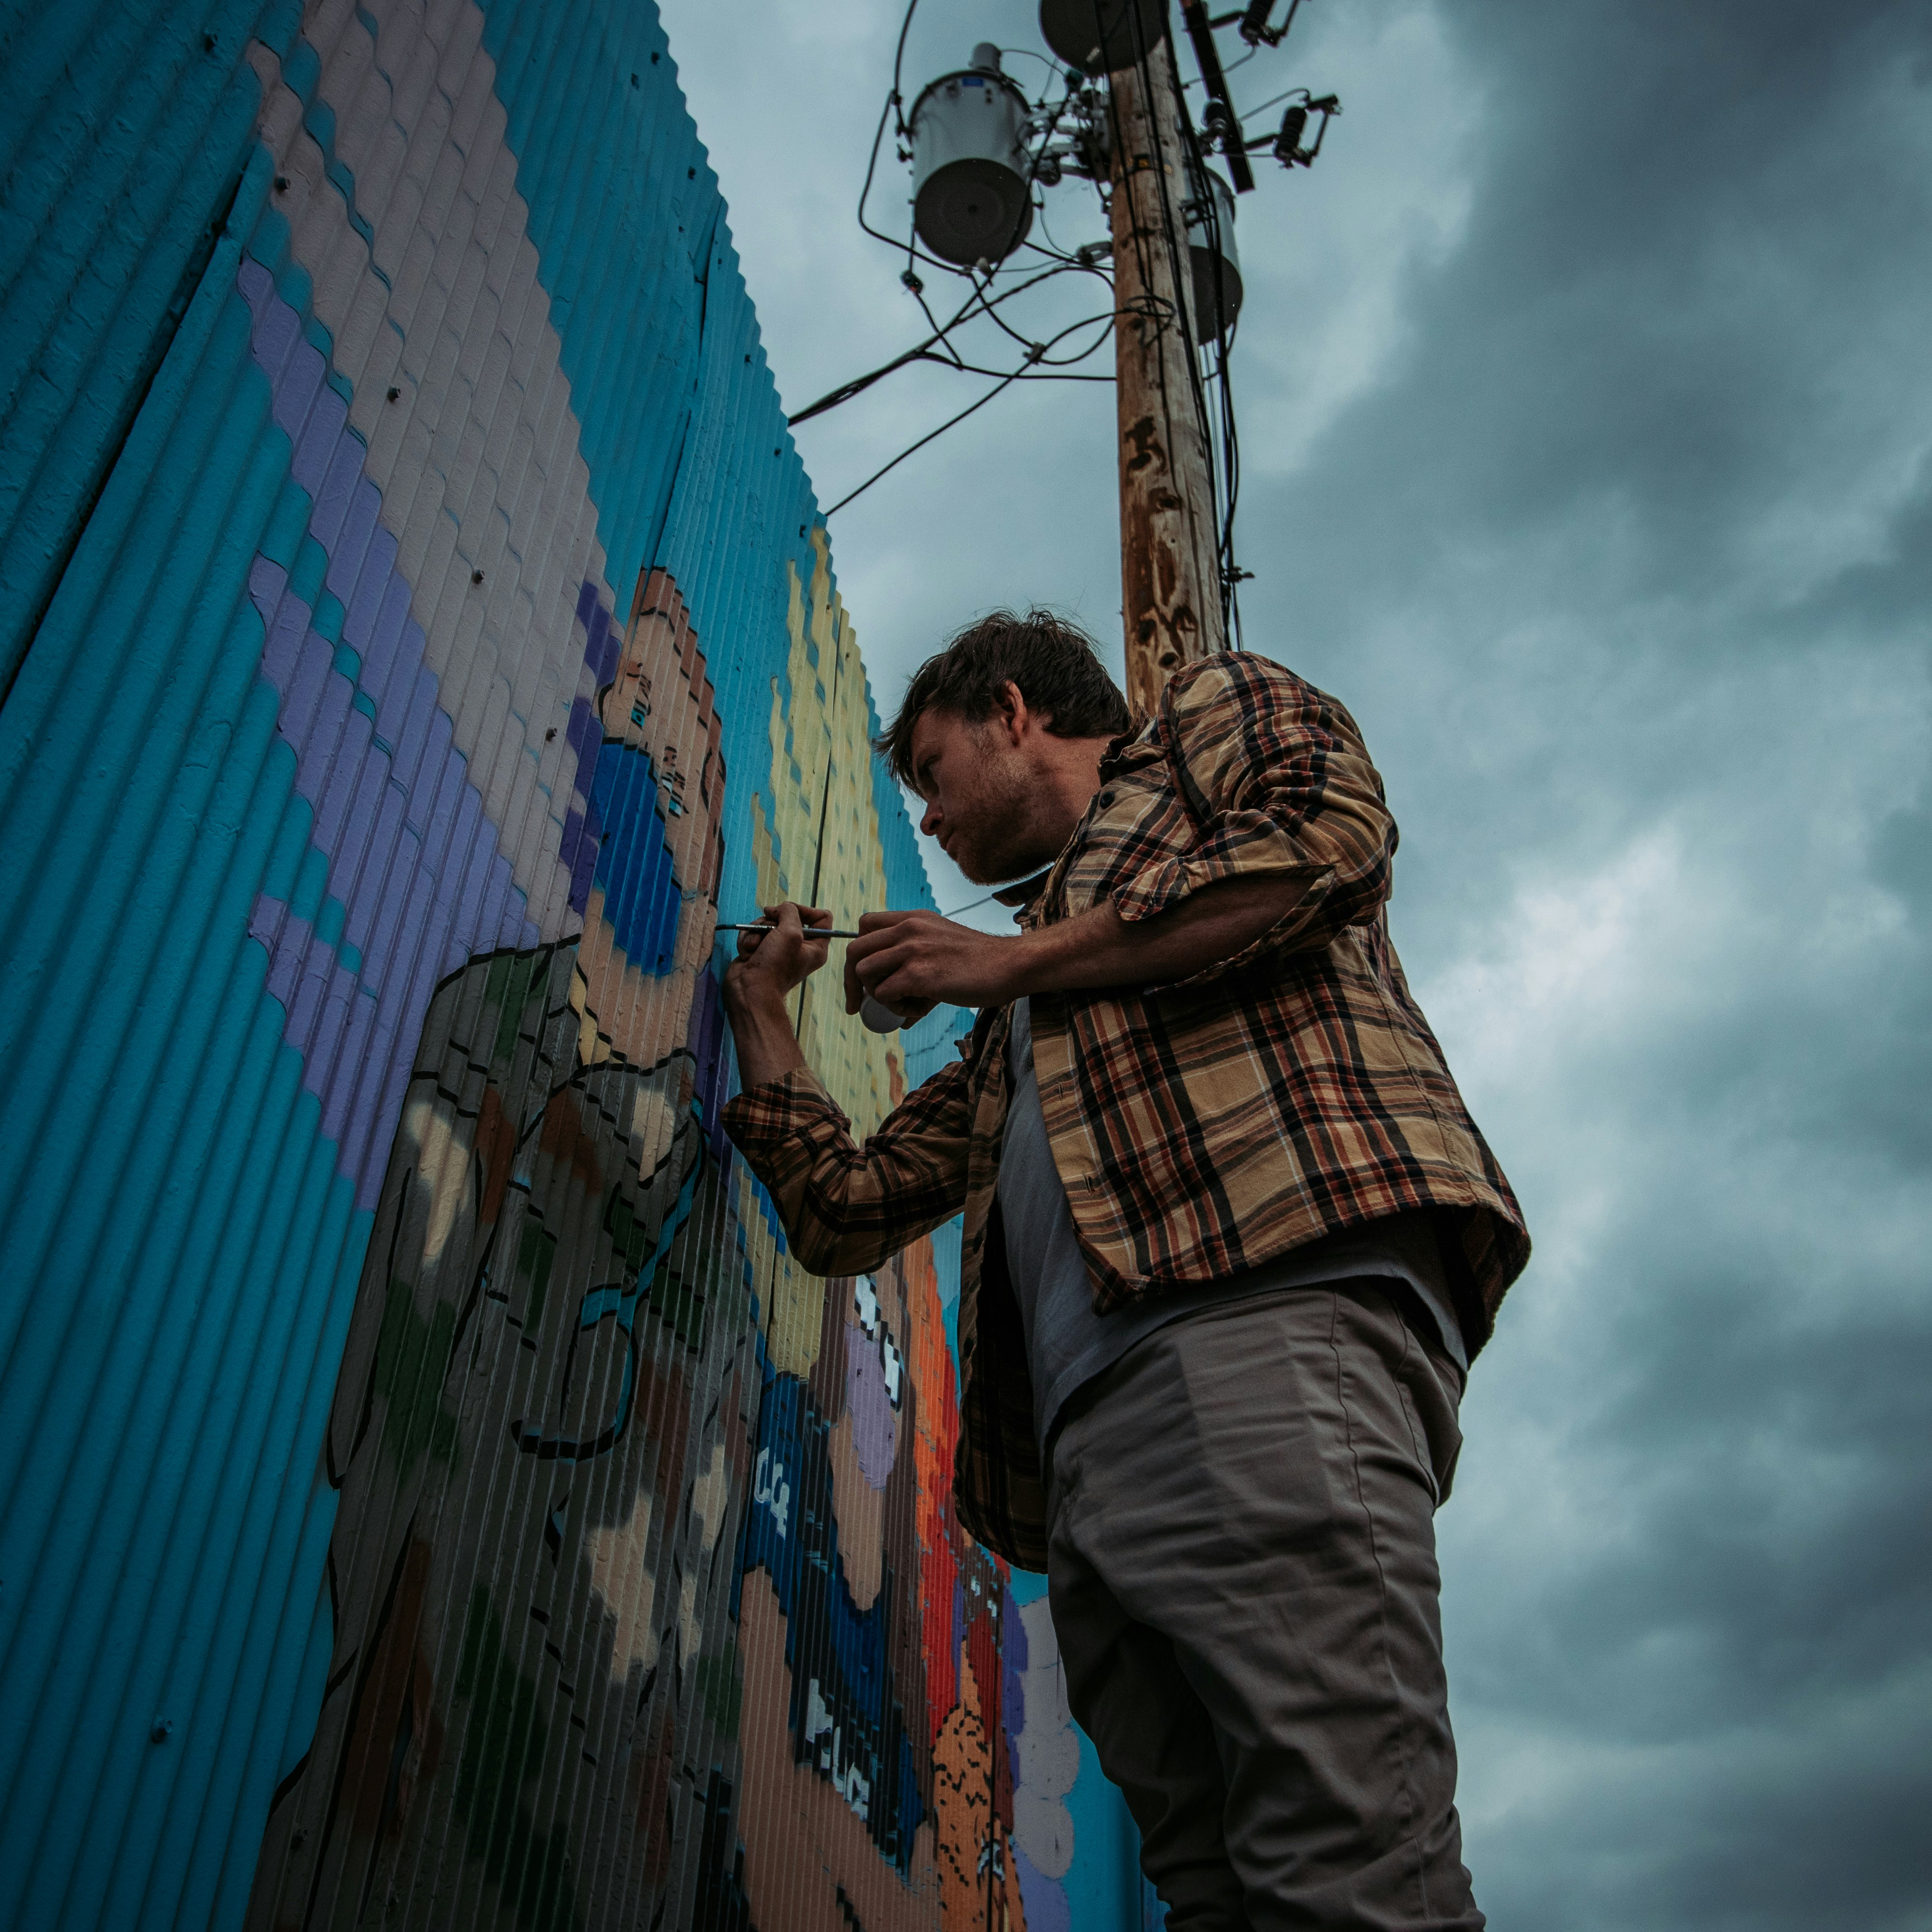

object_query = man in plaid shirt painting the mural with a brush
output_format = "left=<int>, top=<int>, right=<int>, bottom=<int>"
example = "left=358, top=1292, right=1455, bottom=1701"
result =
left=724, top=612, right=1528, bottom=1932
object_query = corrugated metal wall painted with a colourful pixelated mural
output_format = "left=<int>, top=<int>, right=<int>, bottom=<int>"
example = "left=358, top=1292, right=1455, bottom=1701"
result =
left=0, top=0, right=1142, bottom=1932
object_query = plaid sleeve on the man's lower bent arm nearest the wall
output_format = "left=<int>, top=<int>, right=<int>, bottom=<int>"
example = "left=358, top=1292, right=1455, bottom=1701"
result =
left=724, top=1061, right=972, bottom=1275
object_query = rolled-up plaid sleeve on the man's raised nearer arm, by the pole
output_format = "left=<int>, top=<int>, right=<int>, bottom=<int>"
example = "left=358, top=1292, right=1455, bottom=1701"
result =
left=1113, top=651, right=1397, bottom=985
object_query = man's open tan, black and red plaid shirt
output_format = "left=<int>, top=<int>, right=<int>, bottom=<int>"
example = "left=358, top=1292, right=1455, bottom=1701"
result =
left=724, top=653, right=1530, bottom=1569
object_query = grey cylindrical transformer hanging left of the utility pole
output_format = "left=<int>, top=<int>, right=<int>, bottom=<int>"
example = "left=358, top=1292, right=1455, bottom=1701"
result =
left=906, top=43, right=1034, bottom=269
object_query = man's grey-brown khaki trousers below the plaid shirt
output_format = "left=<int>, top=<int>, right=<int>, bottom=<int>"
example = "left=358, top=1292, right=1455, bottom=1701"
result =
left=1049, top=1279, right=1484, bottom=1932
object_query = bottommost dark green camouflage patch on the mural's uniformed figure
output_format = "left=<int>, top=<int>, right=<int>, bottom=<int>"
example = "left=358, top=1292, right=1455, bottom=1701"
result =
left=456, top=1584, right=583, bottom=1932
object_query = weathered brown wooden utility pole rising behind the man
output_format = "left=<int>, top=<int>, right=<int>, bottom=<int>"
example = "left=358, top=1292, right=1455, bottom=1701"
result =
left=1109, top=37, right=1227, bottom=711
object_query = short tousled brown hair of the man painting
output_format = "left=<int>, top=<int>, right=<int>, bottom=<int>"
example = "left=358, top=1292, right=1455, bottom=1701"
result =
left=873, top=609, right=1132, bottom=790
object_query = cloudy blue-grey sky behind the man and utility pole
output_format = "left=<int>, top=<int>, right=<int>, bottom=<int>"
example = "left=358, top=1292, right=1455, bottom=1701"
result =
left=665, top=0, right=1932, bottom=1932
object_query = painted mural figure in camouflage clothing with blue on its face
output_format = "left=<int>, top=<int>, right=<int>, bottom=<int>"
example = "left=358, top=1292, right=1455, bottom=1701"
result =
left=238, top=572, right=759, bottom=1928
